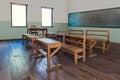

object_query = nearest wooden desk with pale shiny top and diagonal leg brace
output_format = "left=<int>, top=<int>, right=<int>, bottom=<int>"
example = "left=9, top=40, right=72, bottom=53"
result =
left=36, top=38, right=61, bottom=72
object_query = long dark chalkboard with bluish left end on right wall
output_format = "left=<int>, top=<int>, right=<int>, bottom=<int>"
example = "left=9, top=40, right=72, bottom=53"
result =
left=68, top=7, right=120, bottom=28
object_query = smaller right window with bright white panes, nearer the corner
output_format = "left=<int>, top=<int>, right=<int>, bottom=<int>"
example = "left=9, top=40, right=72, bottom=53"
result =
left=42, top=7, right=53, bottom=27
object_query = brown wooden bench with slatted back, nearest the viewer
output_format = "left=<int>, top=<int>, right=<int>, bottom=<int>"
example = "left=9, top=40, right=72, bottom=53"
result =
left=61, top=34, right=86, bottom=64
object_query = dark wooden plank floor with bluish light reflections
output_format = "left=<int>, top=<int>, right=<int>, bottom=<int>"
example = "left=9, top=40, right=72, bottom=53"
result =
left=0, top=40, right=120, bottom=80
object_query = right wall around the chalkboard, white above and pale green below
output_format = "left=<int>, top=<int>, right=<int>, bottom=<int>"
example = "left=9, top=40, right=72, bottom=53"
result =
left=66, top=0, right=120, bottom=43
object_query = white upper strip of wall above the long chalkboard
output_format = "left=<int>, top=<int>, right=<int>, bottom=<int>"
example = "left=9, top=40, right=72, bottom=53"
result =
left=66, top=0, right=120, bottom=12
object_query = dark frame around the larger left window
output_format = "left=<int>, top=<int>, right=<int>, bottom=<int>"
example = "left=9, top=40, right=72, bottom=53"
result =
left=11, top=3, right=28, bottom=28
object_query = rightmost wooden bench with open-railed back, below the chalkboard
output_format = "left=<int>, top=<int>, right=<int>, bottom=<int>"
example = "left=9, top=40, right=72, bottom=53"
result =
left=86, top=30, right=110, bottom=53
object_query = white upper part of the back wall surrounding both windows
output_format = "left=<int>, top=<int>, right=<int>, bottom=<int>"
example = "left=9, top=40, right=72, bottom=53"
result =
left=0, top=0, right=66, bottom=22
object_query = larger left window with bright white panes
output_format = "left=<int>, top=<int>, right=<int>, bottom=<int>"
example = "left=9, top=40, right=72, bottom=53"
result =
left=11, top=3, right=27, bottom=27
